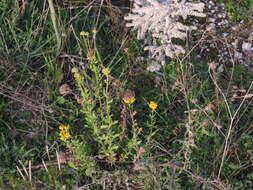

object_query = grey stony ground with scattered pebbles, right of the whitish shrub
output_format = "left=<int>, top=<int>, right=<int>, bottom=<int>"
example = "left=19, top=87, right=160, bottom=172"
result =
left=193, top=0, right=253, bottom=71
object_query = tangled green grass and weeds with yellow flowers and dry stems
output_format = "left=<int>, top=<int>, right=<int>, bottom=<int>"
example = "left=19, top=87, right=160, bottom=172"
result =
left=0, top=0, right=253, bottom=190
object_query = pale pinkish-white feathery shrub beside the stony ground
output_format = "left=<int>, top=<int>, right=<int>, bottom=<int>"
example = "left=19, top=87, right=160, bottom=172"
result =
left=125, top=0, right=205, bottom=71
